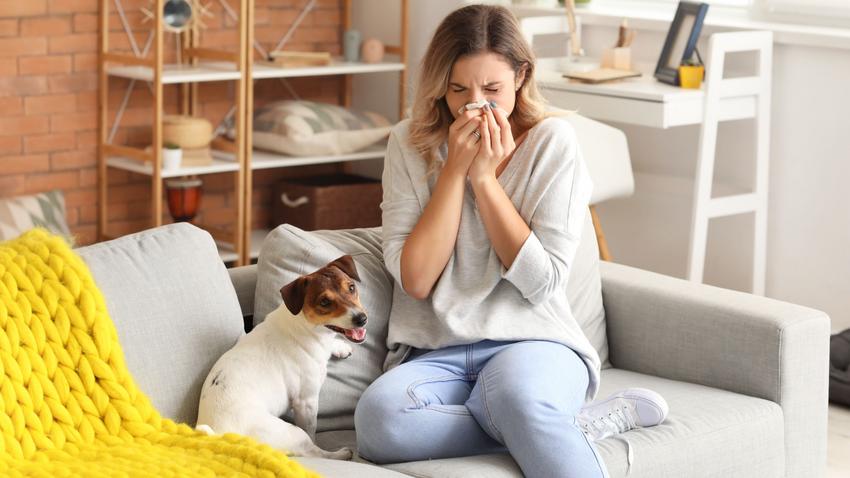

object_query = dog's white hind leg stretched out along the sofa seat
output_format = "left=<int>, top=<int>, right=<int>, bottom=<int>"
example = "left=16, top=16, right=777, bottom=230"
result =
left=248, top=414, right=354, bottom=460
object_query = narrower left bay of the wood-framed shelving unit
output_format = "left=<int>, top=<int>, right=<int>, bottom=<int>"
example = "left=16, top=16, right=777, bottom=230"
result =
left=97, top=0, right=248, bottom=264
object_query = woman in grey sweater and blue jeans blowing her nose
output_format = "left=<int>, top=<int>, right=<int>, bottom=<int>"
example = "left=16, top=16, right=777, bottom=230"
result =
left=355, top=5, right=664, bottom=477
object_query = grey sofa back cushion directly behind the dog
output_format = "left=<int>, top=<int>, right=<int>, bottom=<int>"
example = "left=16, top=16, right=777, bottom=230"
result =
left=254, top=224, right=392, bottom=431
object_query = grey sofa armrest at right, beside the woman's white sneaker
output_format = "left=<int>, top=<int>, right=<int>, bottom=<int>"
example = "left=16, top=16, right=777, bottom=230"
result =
left=600, top=262, right=830, bottom=477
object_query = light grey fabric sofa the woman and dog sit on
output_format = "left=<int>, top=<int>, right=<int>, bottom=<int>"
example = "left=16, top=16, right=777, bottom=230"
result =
left=77, top=219, right=830, bottom=478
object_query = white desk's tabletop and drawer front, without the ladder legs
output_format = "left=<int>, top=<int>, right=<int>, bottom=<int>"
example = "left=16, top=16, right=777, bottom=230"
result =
left=537, top=70, right=756, bottom=129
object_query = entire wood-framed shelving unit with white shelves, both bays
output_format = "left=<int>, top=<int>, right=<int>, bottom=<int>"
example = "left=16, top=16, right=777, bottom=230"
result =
left=98, top=0, right=408, bottom=265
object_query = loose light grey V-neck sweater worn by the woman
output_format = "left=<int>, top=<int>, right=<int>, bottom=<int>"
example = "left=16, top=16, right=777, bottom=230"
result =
left=381, top=118, right=600, bottom=400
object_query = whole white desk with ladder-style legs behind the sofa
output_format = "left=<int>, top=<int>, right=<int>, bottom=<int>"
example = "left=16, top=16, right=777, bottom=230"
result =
left=537, top=32, right=773, bottom=295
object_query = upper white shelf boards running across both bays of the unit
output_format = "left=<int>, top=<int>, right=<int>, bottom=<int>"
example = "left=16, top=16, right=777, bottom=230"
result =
left=107, top=59, right=404, bottom=85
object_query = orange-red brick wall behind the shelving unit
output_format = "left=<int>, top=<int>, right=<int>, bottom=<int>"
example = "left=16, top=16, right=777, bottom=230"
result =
left=0, top=0, right=342, bottom=244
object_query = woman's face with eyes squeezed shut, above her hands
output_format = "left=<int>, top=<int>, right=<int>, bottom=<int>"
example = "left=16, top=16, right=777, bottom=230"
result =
left=446, top=52, right=525, bottom=118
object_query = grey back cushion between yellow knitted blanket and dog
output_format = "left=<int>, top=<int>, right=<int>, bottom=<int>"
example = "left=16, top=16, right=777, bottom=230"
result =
left=77, top=223, right=244, bottom=424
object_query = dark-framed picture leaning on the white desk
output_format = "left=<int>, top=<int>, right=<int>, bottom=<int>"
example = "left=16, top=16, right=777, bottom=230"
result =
left=655, top=2, right=708, bottom=86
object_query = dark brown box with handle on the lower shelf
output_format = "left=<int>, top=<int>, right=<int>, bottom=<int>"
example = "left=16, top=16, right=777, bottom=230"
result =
left=272, top=174, right=383, bottom=231
